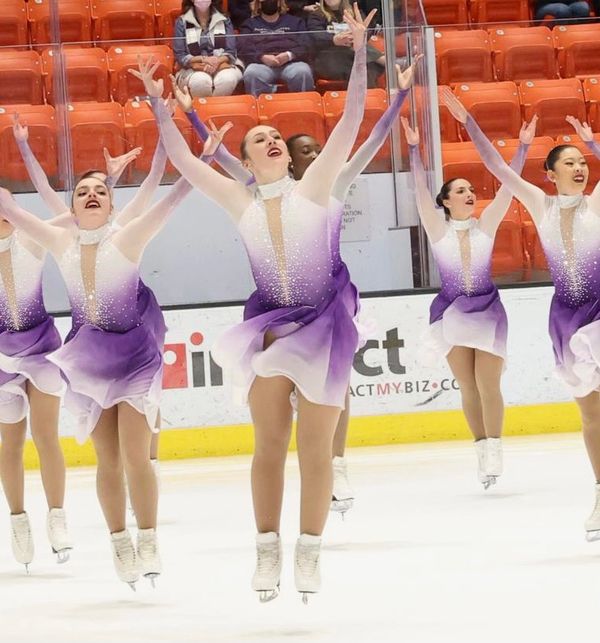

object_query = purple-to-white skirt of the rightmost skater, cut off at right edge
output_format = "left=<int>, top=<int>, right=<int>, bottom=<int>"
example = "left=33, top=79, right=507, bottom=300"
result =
left=549, top=295, right=600, bottom=397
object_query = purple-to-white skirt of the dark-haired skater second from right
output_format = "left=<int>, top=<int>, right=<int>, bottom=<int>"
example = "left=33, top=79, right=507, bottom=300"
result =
left=421, top=286, right=508, bottom=366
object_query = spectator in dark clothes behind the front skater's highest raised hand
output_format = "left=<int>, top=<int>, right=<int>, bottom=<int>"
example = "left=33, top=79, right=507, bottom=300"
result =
left=308, top=0, right=385, bottom=87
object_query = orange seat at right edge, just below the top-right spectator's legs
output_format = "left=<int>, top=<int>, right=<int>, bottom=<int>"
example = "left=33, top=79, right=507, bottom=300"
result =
left=552, top=23, right=600, bottom=78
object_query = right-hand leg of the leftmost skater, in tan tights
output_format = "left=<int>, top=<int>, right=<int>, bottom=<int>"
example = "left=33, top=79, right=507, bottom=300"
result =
left=27, top=382, right=65, bottom=509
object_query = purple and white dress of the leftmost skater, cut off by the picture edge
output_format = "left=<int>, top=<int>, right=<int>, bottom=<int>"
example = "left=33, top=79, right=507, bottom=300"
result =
left=0, top=231, right=64, bottom=424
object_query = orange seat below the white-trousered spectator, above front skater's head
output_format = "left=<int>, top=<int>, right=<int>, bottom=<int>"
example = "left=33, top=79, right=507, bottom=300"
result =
left=192, top=94, right=258, bottom=158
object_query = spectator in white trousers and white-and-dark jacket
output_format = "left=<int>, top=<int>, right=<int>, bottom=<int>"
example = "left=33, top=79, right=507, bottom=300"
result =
left=173, top=0, right=244, bottom=96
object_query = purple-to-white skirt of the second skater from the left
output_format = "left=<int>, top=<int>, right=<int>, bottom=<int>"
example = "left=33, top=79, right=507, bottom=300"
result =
left=49, top=323, right=163, bottom=443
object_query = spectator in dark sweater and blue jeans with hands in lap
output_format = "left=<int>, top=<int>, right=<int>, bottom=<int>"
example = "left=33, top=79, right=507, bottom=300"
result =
left=239, top=0, right=315, bottom=96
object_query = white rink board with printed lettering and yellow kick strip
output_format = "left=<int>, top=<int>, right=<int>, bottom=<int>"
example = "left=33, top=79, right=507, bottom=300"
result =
left=26, top=287, right=580, bottom=467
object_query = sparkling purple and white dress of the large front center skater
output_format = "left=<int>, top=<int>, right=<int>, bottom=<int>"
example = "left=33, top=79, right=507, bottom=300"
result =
left=213, top=177, right=358, bottom=408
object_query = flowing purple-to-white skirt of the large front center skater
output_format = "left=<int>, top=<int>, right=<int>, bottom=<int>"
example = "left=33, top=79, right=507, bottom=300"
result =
left=212, top=266, right=359, bottom=408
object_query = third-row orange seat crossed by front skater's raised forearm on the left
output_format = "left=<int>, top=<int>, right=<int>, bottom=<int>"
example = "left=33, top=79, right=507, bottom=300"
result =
left=123, top=100, right=192, bottom=183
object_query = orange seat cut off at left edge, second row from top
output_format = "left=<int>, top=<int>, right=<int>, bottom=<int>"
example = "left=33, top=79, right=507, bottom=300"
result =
left=0, top=49, right=44, bottom=105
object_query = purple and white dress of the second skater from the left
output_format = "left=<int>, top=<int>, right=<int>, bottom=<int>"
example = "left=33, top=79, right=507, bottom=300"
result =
left=49, top=224, right=163, bottom=442
